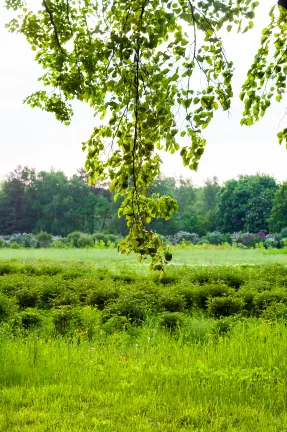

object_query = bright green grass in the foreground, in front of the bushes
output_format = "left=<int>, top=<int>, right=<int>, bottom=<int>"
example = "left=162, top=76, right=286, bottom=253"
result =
left=0, top=321, right=287, bottom=432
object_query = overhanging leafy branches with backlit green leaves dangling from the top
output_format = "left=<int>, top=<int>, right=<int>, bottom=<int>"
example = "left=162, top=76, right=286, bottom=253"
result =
left=5, top=0, right=287, bottom=269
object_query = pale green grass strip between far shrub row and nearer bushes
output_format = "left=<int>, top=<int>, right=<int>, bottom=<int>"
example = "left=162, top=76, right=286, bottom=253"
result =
left=0, top=248, right=287, bottom=268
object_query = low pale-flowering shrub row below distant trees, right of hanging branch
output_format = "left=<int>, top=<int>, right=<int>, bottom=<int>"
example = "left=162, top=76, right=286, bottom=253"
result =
left=166, top=228, right=287, bottom=249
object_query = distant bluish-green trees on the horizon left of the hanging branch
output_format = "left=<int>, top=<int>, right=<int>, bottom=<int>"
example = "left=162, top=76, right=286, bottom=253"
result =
left=0, top=167, right=121, bottom=236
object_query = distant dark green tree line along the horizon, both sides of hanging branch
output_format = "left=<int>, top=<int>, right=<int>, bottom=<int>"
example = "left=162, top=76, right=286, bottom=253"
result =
left=0, top=167, right=287, bottom=236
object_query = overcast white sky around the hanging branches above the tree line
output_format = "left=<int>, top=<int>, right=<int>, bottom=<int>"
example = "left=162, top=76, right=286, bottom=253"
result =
left=0, top=0, right=287, bottom=185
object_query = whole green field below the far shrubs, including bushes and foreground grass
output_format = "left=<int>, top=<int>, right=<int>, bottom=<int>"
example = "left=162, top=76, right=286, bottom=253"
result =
left=0, top=248, right=287, bottom=432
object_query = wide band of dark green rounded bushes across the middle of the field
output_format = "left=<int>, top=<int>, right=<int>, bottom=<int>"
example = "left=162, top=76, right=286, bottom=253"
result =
left=0, top=263, right=287, bottom=333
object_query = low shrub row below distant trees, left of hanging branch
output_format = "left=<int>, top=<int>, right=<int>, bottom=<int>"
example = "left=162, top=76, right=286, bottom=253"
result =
left=0, top=231, right=121, bottom=249
